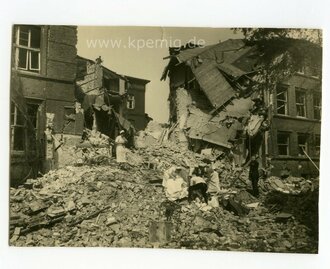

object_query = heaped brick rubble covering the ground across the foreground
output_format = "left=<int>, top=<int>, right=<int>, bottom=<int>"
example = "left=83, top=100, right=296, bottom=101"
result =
left=10, top=140, right=318, bottom=253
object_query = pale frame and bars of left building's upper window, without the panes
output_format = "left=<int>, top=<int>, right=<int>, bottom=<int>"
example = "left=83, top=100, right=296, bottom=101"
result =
left=15, top=25, right=42, bottom=74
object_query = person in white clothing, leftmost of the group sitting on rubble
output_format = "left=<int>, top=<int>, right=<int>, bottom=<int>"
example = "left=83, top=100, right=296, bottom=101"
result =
left=163, top=166, right=188, bottom=201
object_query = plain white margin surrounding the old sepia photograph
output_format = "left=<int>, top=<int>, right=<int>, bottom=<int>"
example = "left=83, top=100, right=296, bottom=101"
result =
left=0, top=0, right=330, bottom=269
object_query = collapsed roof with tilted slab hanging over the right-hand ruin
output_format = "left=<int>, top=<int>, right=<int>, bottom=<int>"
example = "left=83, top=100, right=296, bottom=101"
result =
left=162, top=39, right=256, bottom=109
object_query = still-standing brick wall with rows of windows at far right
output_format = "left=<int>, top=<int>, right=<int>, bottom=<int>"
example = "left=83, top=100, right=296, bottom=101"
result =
left=268, top=74, right=321, bottom=176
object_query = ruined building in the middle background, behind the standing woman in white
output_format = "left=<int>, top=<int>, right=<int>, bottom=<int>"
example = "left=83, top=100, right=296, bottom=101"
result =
left=76, top=56, right=149, bottom=139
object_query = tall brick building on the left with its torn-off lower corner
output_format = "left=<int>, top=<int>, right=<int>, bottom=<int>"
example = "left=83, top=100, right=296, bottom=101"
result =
left=10, top=25, right=83, bottom=183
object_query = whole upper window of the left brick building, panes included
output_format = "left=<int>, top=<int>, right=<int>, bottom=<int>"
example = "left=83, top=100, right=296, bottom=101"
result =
left=15, top=25, right=41, bottom=73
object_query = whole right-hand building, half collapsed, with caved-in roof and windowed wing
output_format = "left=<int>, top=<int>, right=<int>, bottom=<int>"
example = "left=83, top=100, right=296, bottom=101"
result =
left=161, top=36, right=321, bottom=177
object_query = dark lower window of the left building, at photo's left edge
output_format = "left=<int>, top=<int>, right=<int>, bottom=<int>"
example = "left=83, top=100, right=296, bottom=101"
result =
left=10, top=102, right=25, bottom=151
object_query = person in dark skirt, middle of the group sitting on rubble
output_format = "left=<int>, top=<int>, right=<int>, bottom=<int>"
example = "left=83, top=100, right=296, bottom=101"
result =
left=188, top=168, right=208, bottom=204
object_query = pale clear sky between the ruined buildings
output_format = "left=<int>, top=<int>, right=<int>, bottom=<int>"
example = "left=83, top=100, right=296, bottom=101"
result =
left=77, top=26, right=242, bottom=123
